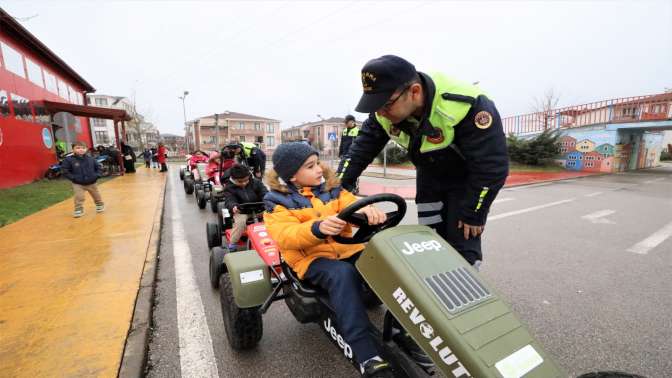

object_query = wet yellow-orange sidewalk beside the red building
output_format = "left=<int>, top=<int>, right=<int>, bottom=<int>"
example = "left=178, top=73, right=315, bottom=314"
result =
left=0, top=168, right=166, bottom=377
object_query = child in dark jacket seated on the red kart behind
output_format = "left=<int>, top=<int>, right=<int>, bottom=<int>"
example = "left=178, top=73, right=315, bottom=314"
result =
left=224, top=164, right=268, bottom=251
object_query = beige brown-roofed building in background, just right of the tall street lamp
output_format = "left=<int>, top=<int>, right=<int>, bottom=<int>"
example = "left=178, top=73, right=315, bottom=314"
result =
left=187, top=111, right=281, bottom=158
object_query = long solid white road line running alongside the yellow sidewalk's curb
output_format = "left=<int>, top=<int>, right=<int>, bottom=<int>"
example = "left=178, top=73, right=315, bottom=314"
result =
left=170, top=175, right=219, bottom=377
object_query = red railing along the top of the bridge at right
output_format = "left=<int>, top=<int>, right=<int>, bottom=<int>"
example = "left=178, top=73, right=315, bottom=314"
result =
left=502, top=93, right=672, bottom=135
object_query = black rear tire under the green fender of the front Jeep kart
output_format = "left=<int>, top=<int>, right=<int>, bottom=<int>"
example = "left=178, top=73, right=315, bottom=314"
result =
left=219, top=273, right=264, bottom=350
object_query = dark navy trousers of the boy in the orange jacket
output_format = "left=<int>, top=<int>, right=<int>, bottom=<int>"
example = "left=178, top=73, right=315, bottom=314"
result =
left=306, top=253, right=378, bottom=364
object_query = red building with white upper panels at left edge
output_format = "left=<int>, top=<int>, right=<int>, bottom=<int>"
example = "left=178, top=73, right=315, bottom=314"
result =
left=0, top=8, right=95, bottom=188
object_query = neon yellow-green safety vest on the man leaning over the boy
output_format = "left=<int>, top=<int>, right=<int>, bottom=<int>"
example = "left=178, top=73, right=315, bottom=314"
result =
left=376, top=73, right=484, bottom=153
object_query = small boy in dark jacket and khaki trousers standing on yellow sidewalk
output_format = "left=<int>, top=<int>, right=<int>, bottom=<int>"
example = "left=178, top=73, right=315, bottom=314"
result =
left=61, top=141, right=105, bottom=218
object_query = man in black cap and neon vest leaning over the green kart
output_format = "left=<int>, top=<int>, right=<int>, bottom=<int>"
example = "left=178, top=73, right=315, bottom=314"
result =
left=342, top=55, right=509, bottom=268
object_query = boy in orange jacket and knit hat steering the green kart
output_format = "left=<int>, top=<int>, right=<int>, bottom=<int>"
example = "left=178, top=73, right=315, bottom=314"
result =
left=264, top=142, right=393, bottom=377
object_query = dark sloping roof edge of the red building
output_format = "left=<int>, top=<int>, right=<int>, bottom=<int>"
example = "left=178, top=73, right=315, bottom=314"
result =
left=0, top=8, right=96, bottom=92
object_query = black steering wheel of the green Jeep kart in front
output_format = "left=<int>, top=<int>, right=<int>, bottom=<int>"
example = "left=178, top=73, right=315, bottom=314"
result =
left=332, top=193, right=406, bottom=244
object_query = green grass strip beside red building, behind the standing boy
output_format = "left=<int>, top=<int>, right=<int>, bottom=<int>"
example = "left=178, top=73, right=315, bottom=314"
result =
left=0, top=177, right=110, bottom=227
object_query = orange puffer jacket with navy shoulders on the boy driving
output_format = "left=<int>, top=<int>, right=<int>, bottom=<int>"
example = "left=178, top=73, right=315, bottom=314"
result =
left=264, top=166, right=364, bottom=279
